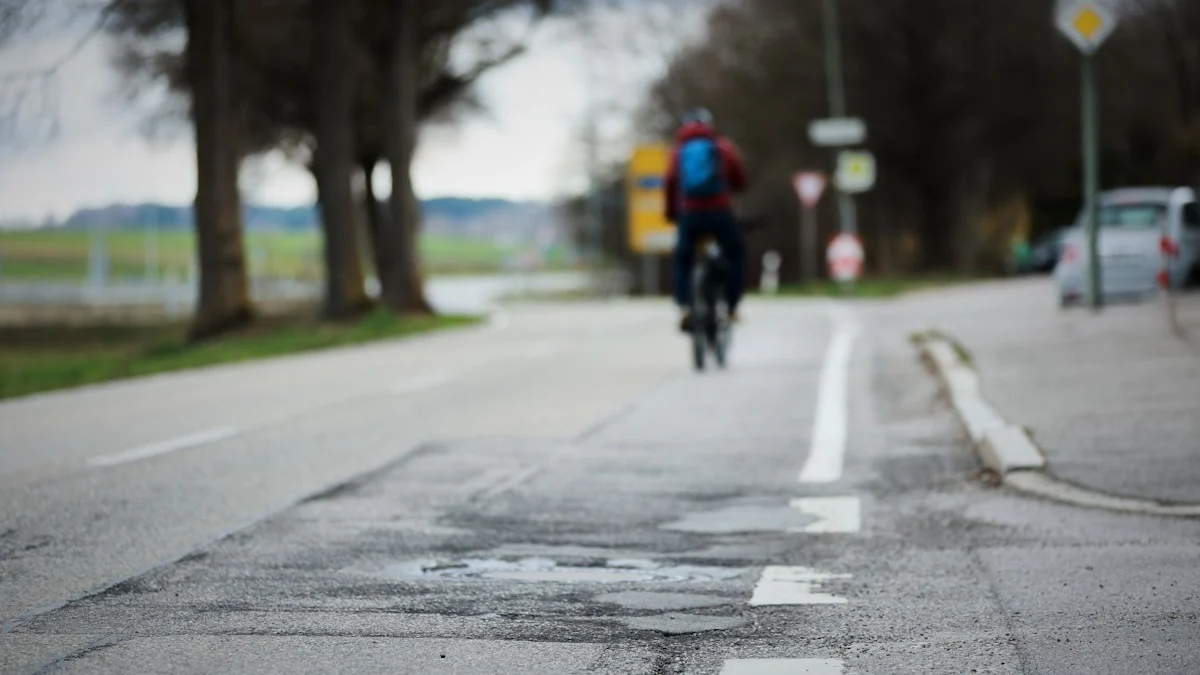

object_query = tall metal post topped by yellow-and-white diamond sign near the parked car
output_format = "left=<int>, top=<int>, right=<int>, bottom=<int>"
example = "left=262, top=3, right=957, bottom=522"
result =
left=1056, top=0, right=1117, bottom=311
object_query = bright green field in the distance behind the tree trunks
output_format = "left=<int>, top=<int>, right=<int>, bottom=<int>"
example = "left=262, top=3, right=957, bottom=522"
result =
left=0, top=229, right=563, bottom=281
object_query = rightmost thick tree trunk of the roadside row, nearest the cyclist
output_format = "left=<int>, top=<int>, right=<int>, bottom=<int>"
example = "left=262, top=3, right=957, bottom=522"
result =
left=379, top=0, right=433, bottom=313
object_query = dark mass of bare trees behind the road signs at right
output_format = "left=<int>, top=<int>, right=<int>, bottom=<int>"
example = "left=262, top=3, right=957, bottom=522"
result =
left=642, top=0, right=1200, bottom=277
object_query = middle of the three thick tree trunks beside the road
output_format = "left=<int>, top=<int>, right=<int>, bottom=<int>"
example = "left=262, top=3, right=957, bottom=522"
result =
left=313, top=0, right=371, bottom=318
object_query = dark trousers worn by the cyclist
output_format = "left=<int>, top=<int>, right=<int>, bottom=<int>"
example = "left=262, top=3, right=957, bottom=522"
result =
left=674, top=209, right=745, bottom=311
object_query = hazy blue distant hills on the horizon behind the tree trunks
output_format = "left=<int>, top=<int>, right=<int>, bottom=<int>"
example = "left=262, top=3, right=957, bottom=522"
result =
left=55, top=197, right=554, bottom=237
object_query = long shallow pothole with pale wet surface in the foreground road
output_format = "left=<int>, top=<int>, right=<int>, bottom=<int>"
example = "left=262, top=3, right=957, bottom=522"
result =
left=364, top=557, right=745, bottom=584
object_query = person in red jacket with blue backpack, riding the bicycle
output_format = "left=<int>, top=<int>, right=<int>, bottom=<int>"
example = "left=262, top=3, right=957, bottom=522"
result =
left=666, top=108, right=746, bottom=331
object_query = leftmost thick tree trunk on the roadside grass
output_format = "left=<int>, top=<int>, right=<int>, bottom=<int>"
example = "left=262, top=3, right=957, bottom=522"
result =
left=184, top=0, right=253, bottom=340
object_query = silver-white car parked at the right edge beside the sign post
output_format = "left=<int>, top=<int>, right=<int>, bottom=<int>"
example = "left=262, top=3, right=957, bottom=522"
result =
left=1055, top=187, right=1200, bottom=306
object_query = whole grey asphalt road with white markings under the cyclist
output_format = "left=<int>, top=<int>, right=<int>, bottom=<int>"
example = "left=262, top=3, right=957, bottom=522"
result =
left=0, top=295, right=1200, bottom=675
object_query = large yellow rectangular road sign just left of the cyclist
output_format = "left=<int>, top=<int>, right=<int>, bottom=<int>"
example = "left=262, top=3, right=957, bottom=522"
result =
left=625, top=144, right=676, bottom=253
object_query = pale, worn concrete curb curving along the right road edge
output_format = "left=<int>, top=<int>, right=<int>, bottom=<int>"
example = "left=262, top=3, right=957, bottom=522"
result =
left=916, top=331, right=1200, bottom=516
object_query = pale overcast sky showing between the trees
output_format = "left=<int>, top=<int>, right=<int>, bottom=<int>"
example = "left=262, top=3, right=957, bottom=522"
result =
left=0, top=2, right=702, bottom=219
